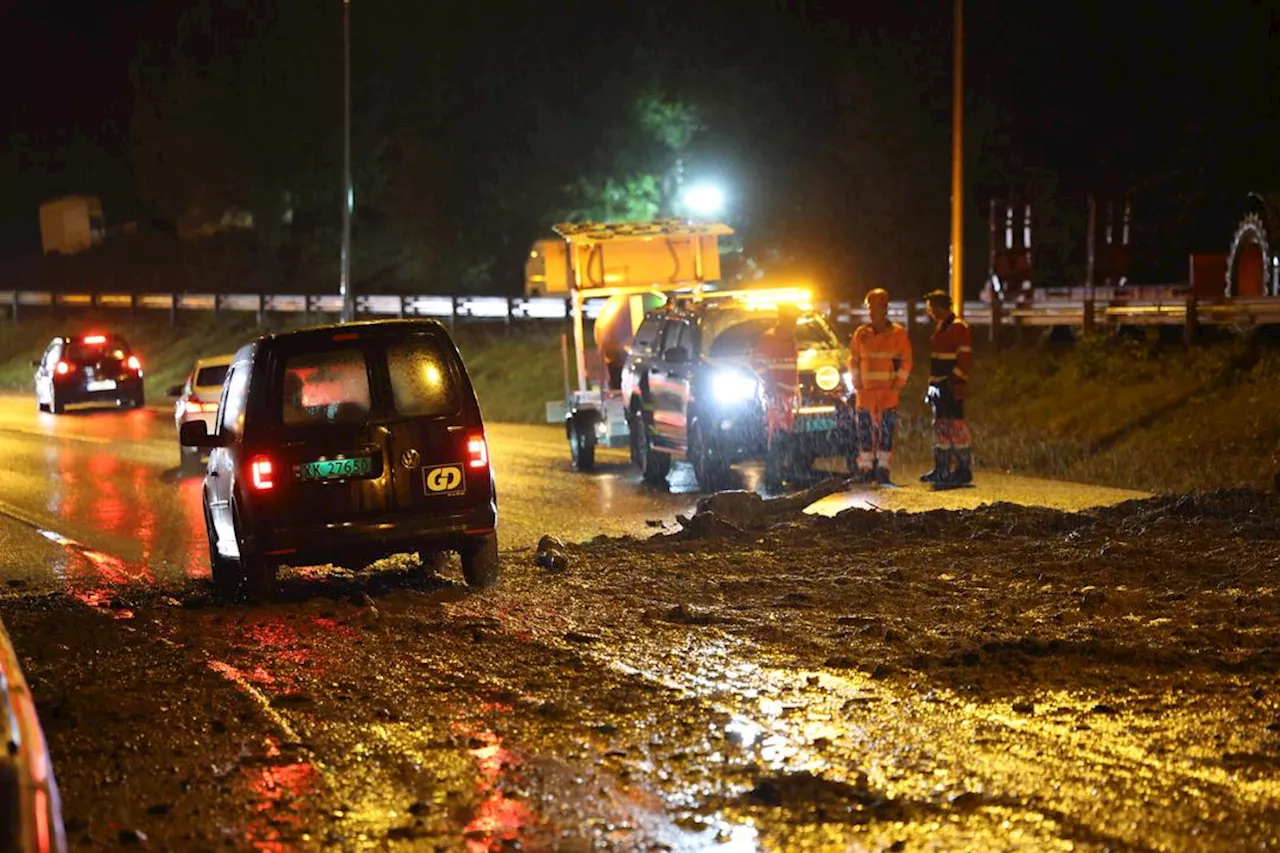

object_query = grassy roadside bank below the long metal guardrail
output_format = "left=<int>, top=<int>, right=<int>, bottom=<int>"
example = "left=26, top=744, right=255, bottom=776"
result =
left=0, top=315, right=1280, bottom=492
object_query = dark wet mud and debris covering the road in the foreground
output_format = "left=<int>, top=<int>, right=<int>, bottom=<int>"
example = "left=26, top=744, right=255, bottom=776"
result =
left=0, top=481, right=1280, bottom=850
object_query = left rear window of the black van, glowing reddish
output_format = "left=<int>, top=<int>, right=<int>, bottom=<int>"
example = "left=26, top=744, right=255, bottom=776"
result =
left=282, top=348, right=370, bottom=427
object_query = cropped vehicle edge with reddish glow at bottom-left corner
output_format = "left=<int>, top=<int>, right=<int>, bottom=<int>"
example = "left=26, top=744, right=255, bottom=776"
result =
left=0, top=624, right=67, bottom=853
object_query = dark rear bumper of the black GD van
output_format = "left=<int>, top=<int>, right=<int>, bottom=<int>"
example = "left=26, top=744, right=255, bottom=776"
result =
left=255, top=502, right=498, bottom=566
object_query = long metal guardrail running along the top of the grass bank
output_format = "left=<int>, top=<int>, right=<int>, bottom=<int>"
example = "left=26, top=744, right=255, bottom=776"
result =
left=0, top=287, right=1280, bottom=333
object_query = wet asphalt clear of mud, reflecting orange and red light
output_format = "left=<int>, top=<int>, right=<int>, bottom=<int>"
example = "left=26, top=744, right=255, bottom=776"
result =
left=0, top=396, right=1138, bottom=584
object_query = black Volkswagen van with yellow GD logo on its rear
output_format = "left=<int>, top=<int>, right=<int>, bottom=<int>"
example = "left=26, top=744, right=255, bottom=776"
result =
left=180, top=320, right=498, bottom=597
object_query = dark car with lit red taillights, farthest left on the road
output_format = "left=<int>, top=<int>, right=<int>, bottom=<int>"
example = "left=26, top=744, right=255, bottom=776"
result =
left=31, top=333, right=145, bottom=415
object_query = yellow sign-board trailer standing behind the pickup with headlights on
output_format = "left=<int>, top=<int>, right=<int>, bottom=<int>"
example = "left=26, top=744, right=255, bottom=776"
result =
left=549, top=219, right=733, bottom=471
